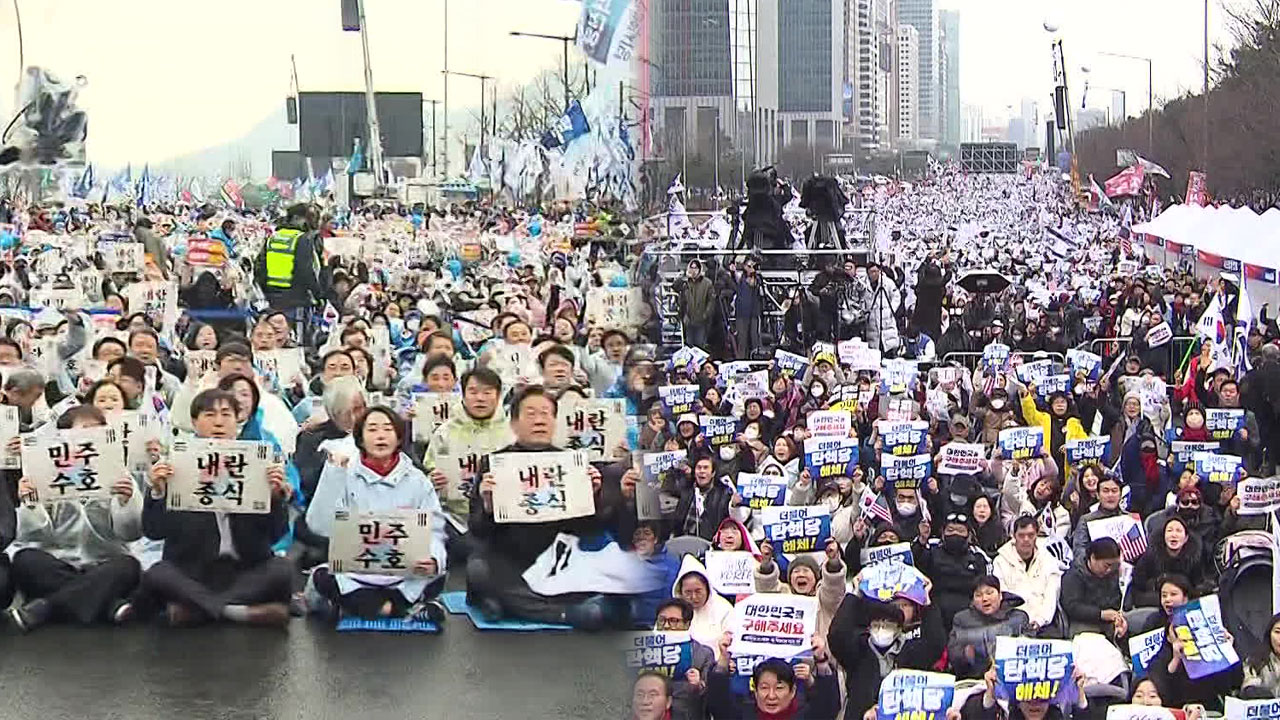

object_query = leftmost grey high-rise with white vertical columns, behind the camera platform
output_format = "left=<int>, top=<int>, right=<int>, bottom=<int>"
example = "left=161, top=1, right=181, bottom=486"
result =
left=641, top=0, right=778, bottom=164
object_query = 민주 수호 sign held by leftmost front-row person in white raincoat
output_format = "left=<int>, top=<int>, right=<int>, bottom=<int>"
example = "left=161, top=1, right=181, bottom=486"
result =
left=22, top=427, right=128, bottom=502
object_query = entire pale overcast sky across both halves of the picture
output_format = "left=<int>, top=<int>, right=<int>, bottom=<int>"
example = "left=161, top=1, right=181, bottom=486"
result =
left=0, top=0, right=1248, bottom=165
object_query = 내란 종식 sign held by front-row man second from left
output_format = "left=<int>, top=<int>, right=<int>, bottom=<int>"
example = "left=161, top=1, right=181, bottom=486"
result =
left=165, top=438, right=275, bottom=515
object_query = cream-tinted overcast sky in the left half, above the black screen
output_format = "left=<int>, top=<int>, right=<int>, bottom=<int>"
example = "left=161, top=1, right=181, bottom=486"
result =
left=0, top=0, right=581, bottom=165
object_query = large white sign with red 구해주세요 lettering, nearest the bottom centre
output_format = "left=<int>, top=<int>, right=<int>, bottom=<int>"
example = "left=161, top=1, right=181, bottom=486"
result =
left=730, top=593, right=818, bottom=660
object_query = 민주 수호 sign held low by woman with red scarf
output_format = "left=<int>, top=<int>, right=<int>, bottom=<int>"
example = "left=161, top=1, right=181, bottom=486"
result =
left=329, top=510, right=444, bottom=575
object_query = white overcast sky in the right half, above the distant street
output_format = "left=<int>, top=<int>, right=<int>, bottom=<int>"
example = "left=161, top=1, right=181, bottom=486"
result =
left=940, top=0, right=1248, bottom=117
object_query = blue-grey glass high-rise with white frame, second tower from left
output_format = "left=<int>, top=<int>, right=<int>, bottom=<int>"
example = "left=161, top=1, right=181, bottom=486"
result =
left=776, top=0, right=846, bottom=149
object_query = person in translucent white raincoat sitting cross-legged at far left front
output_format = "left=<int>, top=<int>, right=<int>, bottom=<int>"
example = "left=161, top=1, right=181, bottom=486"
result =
left=8, top=405, right=142, bottom=632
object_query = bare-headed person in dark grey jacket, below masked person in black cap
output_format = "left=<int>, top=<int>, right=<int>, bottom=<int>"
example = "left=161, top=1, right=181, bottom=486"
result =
left=947, top=575, right=1032, bottom=679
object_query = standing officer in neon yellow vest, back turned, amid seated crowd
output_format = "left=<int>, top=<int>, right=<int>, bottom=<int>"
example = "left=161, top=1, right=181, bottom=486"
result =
left=255, top=205, right=329, bottom=310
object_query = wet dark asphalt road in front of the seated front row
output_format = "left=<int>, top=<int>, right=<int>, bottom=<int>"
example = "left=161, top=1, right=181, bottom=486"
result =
left=0, top=615, right=630, bottom=720
